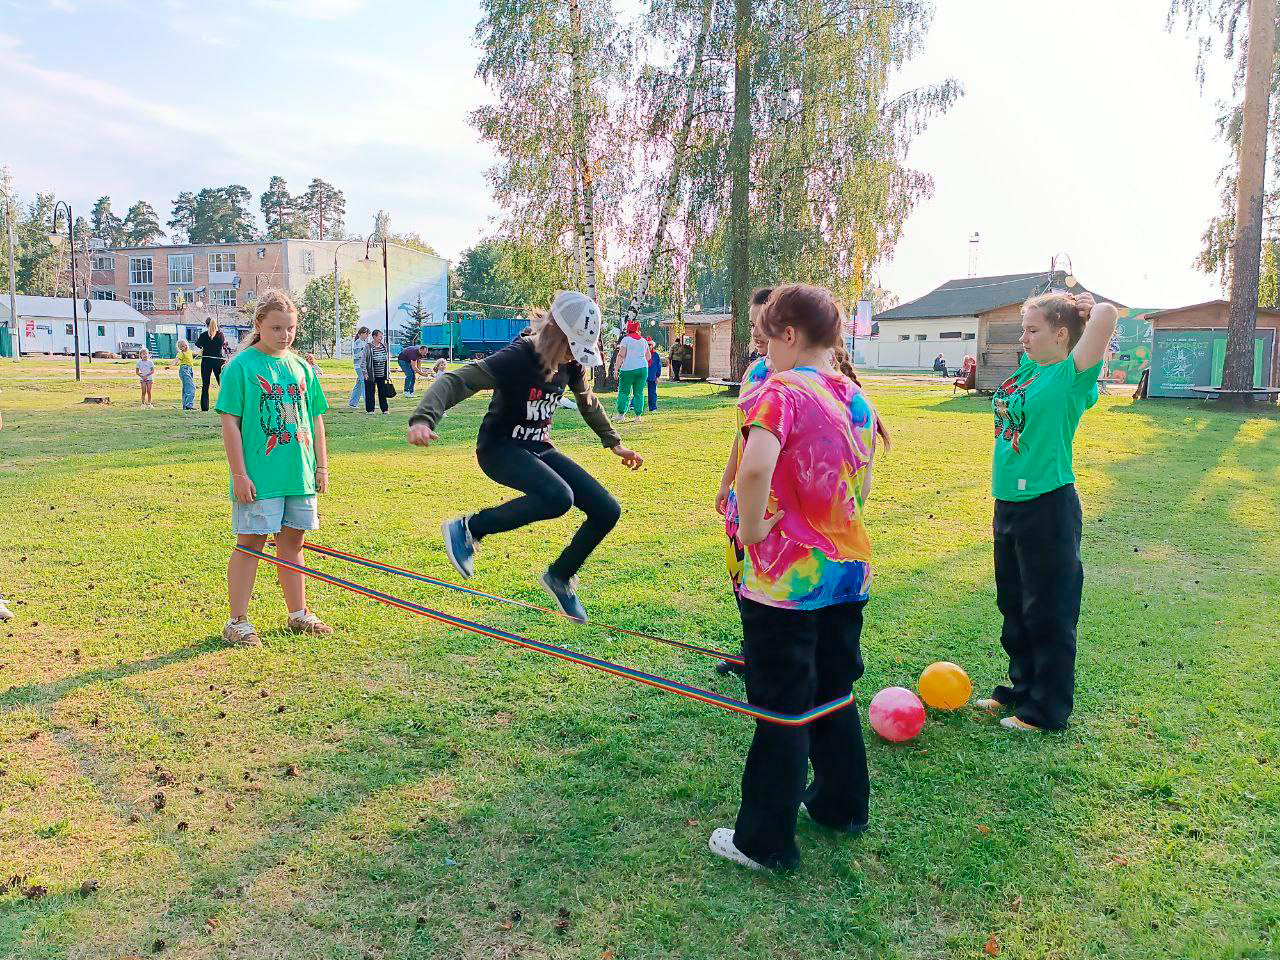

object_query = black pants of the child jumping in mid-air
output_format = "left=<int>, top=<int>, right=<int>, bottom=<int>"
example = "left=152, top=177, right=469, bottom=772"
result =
left=467, top=443, right=622, bottom=580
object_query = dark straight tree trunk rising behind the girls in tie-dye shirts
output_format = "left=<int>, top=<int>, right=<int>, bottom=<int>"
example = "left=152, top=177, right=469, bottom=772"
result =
left=728, top=0, right=753, bottom=380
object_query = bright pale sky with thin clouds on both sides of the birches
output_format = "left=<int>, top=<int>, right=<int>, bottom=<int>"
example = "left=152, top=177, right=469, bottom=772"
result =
left=0, top=0, right=1231, bottom=307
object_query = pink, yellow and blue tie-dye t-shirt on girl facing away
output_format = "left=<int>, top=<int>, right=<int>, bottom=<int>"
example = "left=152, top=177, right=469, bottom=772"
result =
left=739, top=367, right=876, bottom=609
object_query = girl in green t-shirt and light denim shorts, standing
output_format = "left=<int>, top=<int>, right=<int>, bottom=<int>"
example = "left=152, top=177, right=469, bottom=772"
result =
left=218, top=291, right=333, bottom=646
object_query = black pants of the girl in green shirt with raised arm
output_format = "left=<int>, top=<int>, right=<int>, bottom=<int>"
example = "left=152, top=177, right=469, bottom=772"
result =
left=992, top=484, right=1084, bottom=730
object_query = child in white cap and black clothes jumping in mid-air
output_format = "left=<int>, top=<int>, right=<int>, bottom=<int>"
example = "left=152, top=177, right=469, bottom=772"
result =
left=408, top=292, right=644, bottom=623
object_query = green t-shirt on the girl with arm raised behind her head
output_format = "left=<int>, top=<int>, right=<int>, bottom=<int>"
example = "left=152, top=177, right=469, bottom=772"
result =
left=991, top=357, right=1102, bottom=500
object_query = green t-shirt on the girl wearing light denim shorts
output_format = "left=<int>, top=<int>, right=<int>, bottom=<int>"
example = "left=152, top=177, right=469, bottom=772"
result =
left=216, top=347, right=329, bottom=500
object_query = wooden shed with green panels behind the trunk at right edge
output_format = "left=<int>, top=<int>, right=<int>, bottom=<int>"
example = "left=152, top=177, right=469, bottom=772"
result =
left=1146, top=300, right=1280, bottom=397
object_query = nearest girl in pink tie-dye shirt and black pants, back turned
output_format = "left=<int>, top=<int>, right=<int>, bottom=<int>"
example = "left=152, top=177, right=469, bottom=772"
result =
left=709, top=284, right=877, bottom=869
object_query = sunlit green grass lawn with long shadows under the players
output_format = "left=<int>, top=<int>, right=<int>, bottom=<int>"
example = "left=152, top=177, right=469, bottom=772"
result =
left=0, top=360, right=1280, bottom=960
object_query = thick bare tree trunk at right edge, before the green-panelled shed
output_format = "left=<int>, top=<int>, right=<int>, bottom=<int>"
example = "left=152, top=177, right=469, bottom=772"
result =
left=1222, top=0, right=1276, bottom=402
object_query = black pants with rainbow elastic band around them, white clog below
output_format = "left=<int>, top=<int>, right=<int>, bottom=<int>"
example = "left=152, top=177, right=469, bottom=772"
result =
left=733, top=598, right=870, bottom=868
